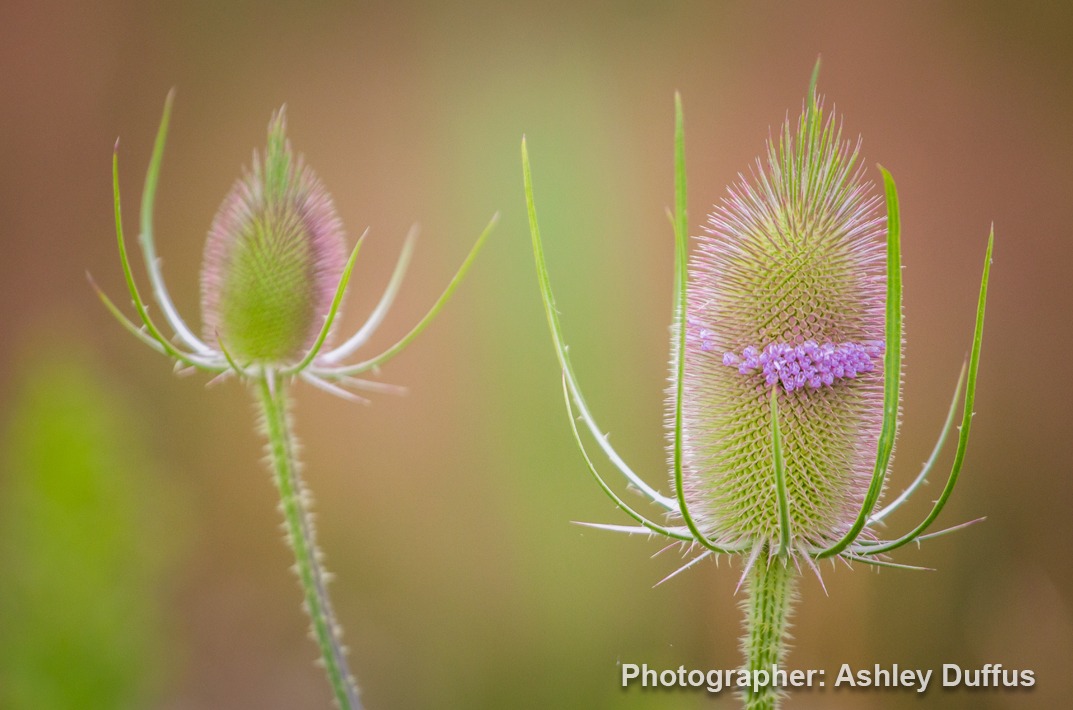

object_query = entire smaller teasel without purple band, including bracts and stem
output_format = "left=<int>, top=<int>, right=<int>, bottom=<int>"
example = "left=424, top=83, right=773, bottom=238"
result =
left=94, top=94, right=496, bottom=710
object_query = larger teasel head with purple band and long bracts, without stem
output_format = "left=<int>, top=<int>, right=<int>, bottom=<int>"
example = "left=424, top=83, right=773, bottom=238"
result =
left=521, top=63, right=994, bottom=579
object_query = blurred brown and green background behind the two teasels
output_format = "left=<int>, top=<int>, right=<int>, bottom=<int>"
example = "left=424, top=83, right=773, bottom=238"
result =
left=0, top=0, right=1073, bottom=710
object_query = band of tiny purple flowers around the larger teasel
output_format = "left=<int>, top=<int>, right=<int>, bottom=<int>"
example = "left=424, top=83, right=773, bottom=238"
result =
left=716, top=339, right=884, bottom=391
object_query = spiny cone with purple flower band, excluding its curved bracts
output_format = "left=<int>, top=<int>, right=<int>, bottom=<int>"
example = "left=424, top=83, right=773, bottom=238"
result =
left=681, top=97, right=886, bottom=549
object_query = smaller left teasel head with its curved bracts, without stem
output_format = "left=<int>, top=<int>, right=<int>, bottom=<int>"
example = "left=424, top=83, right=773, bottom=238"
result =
left=94, top=89, right=497, bottom=401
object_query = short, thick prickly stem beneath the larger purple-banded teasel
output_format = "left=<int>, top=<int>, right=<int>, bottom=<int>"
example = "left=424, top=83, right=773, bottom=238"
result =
left=741, top=552, right=797, bottom=710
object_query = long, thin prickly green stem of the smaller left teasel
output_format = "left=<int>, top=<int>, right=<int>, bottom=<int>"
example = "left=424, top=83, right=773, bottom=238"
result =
left=258, top=372, right=362, bottom=710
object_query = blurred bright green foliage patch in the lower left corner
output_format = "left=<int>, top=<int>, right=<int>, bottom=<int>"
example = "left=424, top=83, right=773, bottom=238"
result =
left=0, top=354, right=180, bottom=710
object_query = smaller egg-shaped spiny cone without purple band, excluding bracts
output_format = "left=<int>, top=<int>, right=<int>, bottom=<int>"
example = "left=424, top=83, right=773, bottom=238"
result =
left=202, top=108, right=347, bottom=365
